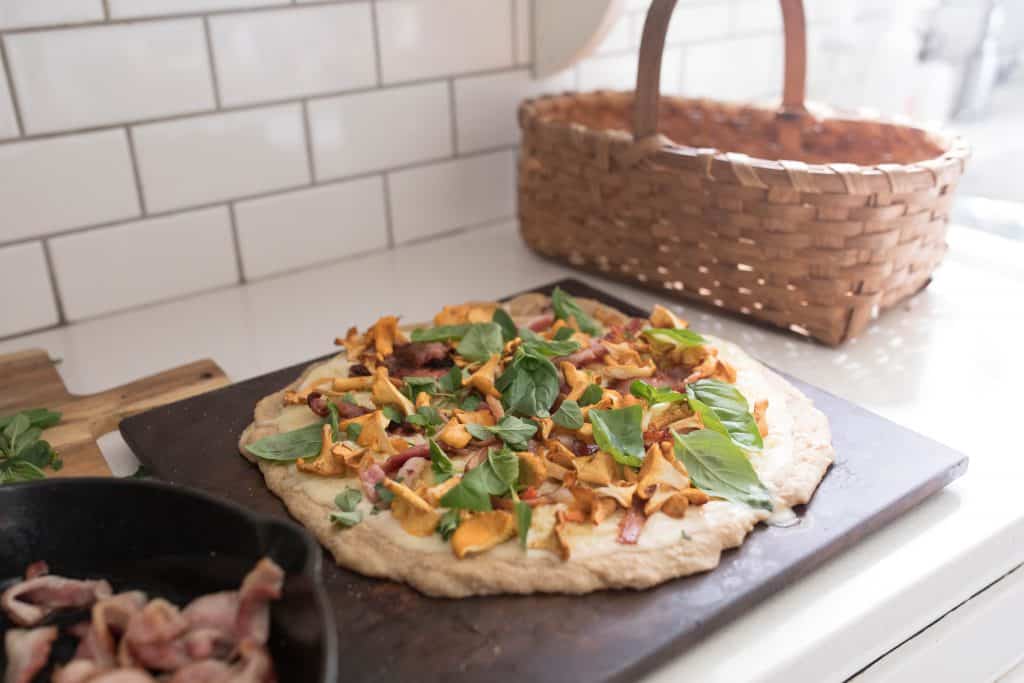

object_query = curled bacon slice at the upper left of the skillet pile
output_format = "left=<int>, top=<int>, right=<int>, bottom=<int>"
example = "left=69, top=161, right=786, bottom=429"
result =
left=0, top=574, right=113, bottom=627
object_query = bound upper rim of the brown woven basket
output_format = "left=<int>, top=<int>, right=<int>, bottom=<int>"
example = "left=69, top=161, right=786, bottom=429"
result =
left=519, top=89, right=971, bottom=195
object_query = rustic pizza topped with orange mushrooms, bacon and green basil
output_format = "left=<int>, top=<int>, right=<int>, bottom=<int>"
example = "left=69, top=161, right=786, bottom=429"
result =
left=240, top=289, right=834, bottom=597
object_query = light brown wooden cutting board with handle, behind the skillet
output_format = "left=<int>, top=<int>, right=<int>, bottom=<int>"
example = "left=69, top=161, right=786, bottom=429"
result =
left=0, top=348, right=230, bottom=476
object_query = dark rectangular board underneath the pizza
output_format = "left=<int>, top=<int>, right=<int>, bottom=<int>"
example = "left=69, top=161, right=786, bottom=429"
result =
left=121, top=280, right=967, bottom=683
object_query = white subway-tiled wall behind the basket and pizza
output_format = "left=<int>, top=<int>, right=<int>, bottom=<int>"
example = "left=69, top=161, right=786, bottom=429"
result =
left=0, top=0, right=880, bottom=337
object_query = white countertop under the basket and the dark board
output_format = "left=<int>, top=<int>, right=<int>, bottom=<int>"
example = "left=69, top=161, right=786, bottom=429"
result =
left=0, top=222, right=1024, bottom=683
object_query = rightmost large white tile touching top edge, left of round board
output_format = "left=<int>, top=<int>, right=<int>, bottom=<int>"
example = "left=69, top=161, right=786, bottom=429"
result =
left=377, top=0, right=512, bottom=83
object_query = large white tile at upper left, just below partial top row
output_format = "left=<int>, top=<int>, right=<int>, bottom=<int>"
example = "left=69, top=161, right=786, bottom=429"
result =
left=5, top=19, right=214, bottom=133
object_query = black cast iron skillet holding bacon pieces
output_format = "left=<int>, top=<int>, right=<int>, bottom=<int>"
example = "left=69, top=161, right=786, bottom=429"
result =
left=0, top=478, right=338, bottom=683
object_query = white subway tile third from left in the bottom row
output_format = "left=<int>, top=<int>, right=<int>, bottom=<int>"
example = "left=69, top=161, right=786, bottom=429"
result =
left=234, top=175, right=387, bottom=279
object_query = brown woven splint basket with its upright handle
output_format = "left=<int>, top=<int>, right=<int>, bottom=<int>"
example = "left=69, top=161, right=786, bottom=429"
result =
left=519, top=0, right=968, bottom=345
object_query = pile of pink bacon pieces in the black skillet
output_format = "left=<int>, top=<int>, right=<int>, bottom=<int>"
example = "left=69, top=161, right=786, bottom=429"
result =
left=4, top=558, right=285, bottom=683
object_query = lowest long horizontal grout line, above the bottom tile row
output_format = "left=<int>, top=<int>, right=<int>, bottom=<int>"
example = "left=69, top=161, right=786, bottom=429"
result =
left=0, top=144, right=518, bottom=248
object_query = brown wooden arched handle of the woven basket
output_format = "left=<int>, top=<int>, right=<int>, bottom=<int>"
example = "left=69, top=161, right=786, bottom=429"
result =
left=633, top=0, right=807, bottom=150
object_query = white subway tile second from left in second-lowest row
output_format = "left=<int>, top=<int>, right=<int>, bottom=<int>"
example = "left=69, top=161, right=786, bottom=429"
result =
left=133, top=104, right=309, bottom=211
